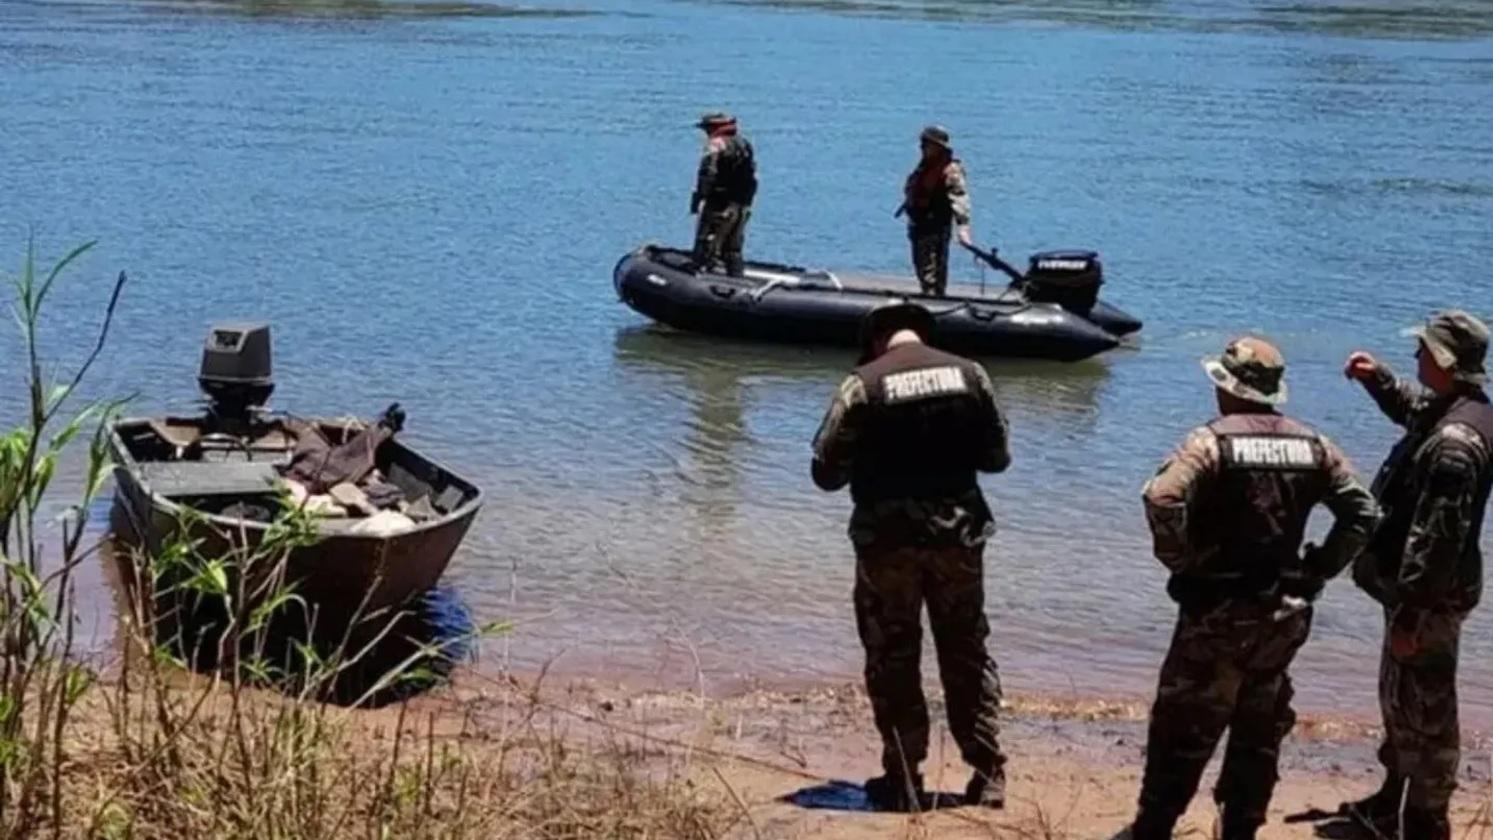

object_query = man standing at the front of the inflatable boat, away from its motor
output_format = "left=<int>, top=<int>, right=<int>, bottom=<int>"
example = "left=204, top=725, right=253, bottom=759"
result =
left=690, top=112, right=757, bottom=278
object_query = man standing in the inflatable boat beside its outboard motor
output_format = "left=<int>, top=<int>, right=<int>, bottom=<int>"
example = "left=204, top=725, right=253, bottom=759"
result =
left=897, top=125, right=973, bottom=297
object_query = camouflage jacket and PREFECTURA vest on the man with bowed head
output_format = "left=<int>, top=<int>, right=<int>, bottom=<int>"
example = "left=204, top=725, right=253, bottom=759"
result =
left=814, top=342, right=1011, bottom=546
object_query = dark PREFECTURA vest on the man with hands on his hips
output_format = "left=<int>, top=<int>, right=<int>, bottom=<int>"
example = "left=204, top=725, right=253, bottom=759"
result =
left=1173, top=413, right=1332, bottom=600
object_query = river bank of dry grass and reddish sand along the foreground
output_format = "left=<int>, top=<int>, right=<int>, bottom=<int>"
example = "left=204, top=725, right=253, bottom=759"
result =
left=20, top=614, right=1493, bottom=840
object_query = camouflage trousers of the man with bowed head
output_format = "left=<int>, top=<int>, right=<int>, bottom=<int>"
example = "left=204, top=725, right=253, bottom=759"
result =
left=854, top=543, right=1006, bottom=773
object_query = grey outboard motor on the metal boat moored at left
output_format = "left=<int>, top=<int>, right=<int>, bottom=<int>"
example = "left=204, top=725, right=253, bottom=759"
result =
left=197, top=324, right=275, bottom=431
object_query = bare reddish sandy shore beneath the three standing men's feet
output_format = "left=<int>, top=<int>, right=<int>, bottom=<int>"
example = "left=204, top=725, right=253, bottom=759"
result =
left=438, top=673, right=1493, bottom=840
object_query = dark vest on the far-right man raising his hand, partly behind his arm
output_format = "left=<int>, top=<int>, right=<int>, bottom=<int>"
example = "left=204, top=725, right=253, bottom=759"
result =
left=1365, top=397, right=1493, bottom=609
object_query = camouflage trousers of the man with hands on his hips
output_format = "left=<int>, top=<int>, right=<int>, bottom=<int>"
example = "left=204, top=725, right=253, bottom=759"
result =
left=1141, top=600, right=1311, bottom=827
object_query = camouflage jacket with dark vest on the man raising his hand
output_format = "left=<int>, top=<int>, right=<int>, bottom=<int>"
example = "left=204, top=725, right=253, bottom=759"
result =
left=1353, top=369, right=1493, bottom=613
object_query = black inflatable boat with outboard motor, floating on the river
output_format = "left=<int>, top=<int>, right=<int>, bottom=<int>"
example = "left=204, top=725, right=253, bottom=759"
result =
left=612, top=245, right=1141, bottom=361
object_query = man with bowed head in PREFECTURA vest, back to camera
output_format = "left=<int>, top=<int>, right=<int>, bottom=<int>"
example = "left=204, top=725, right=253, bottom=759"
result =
left=812, top=303, right=1011, bottom=810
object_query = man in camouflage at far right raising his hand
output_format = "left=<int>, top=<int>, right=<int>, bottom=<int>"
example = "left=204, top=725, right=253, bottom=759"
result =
left=1344, top=310, right=1493, bottom=840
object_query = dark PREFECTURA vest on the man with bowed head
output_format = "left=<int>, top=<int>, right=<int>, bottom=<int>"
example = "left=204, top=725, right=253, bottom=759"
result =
left=850, top=343, right=993, bottom=504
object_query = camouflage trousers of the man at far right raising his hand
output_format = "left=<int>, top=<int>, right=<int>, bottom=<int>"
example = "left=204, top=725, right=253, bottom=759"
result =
left=1380, top=607, right=1466, bottom=812
